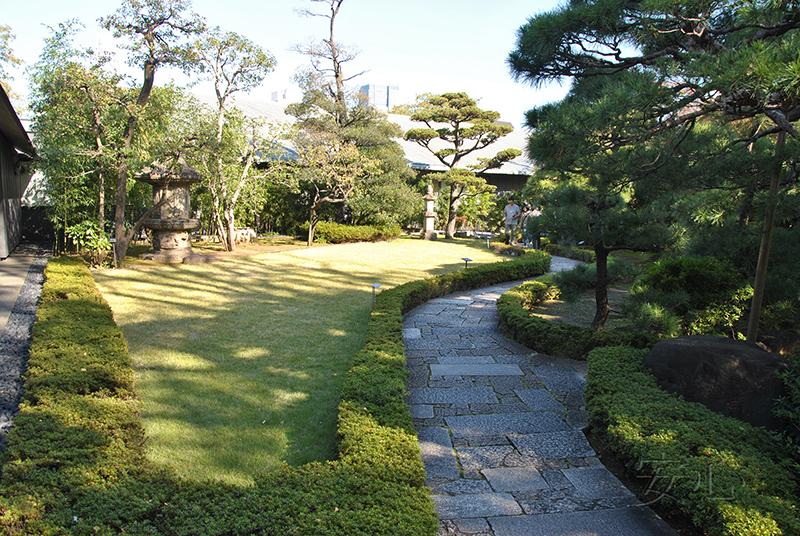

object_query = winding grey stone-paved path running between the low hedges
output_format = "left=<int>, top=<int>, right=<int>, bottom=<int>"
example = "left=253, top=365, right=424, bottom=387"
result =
left=403, top=258, right=676, bottom=536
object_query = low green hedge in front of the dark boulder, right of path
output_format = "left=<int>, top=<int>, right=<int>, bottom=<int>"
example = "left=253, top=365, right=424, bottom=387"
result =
left=586, top=347, right=800, bottom=536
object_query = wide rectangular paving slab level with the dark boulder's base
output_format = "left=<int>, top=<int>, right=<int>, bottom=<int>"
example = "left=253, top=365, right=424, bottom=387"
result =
left=445, top=411, right=568, bottom=441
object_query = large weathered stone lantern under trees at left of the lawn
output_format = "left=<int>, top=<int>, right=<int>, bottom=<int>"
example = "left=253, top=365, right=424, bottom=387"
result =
left=136, top=158, right=211, bottom=263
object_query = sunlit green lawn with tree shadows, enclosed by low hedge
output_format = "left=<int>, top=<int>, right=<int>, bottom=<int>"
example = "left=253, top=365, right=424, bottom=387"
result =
left=94, top=238, right=501, bottom=485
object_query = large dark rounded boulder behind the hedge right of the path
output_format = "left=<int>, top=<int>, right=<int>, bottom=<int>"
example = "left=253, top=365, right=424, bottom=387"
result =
left=644, top=335, right=788, bottom=430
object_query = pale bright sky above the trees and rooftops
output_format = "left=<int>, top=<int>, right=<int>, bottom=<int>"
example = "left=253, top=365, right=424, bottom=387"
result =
left=0, top=0, right=568, bottom=128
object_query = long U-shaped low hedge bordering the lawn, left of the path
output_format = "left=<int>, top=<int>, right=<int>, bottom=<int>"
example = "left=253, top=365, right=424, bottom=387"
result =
left=0, top=252, right=550, bottom=536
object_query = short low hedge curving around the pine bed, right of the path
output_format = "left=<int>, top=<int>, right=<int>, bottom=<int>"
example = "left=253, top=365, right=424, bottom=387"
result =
left=497, top=280, right=658, bottom=359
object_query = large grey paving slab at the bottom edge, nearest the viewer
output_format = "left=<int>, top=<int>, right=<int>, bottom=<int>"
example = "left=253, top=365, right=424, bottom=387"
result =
left=489, top=507, right=677, bottom=536
